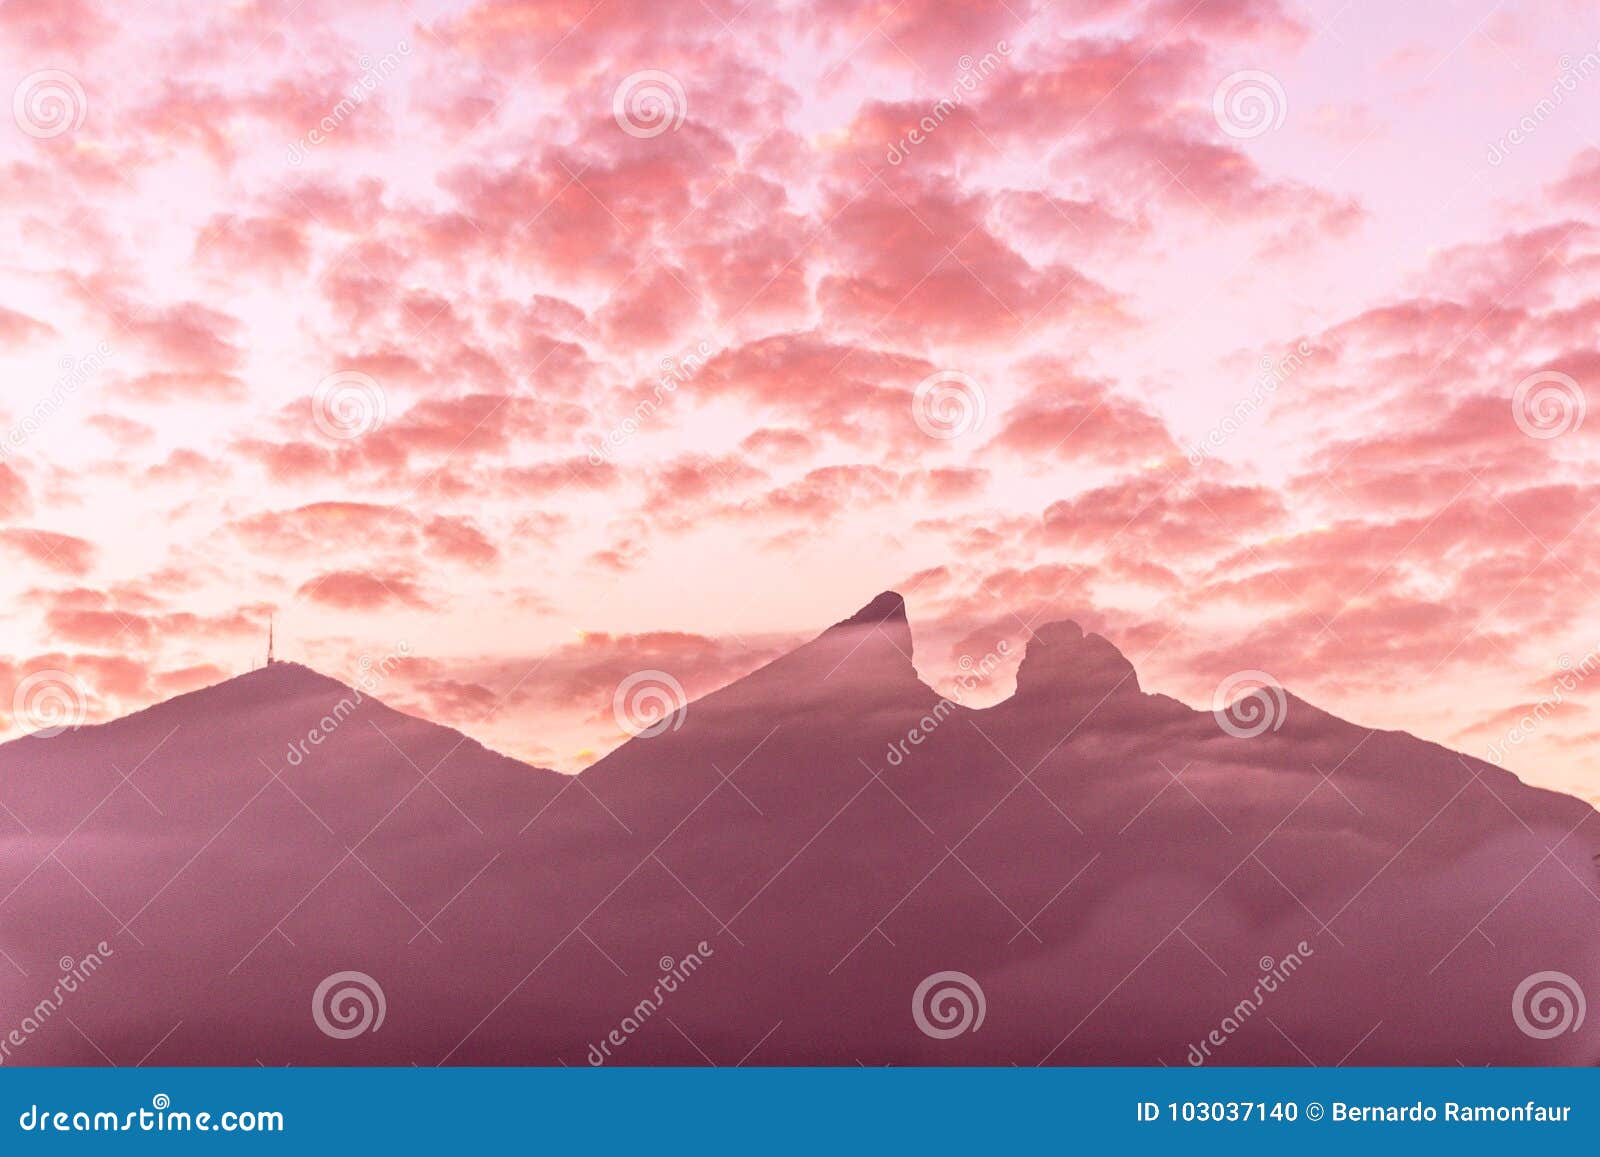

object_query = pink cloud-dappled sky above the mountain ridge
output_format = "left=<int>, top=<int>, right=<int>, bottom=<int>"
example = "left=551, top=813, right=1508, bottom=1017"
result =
left=0, top=0, right=1600, bottom=799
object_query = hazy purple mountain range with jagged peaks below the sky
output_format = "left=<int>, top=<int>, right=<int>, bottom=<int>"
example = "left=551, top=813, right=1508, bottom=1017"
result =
left=0, top=594, right=1600, bottom=1064
